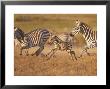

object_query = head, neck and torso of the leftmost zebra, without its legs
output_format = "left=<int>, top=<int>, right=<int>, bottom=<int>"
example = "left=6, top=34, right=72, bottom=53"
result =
left=14, top=29, right=50, bottom=47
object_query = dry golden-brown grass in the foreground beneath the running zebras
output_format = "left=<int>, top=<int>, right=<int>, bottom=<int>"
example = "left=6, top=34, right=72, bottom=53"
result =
left=15, top=48, right=97, bottom=76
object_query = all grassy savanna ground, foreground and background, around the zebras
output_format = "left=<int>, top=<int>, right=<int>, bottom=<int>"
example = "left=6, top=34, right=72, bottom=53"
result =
left=14, top=14, right=97, bottom=76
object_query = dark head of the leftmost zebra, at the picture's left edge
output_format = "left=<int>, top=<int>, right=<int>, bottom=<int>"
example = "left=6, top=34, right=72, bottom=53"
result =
left=14, top=27, right=25, bottom=43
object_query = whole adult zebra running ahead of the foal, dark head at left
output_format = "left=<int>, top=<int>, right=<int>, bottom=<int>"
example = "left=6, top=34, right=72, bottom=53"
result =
left=14, top=27, right=50, bottom=56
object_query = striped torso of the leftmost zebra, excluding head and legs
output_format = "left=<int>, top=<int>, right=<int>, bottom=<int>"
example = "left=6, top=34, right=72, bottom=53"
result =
left=25, top=29, right=50, bottom=47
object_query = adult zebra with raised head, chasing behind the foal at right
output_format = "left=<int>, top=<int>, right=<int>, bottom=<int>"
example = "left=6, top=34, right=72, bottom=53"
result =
left=70, top=20, right=97, bottom=58
